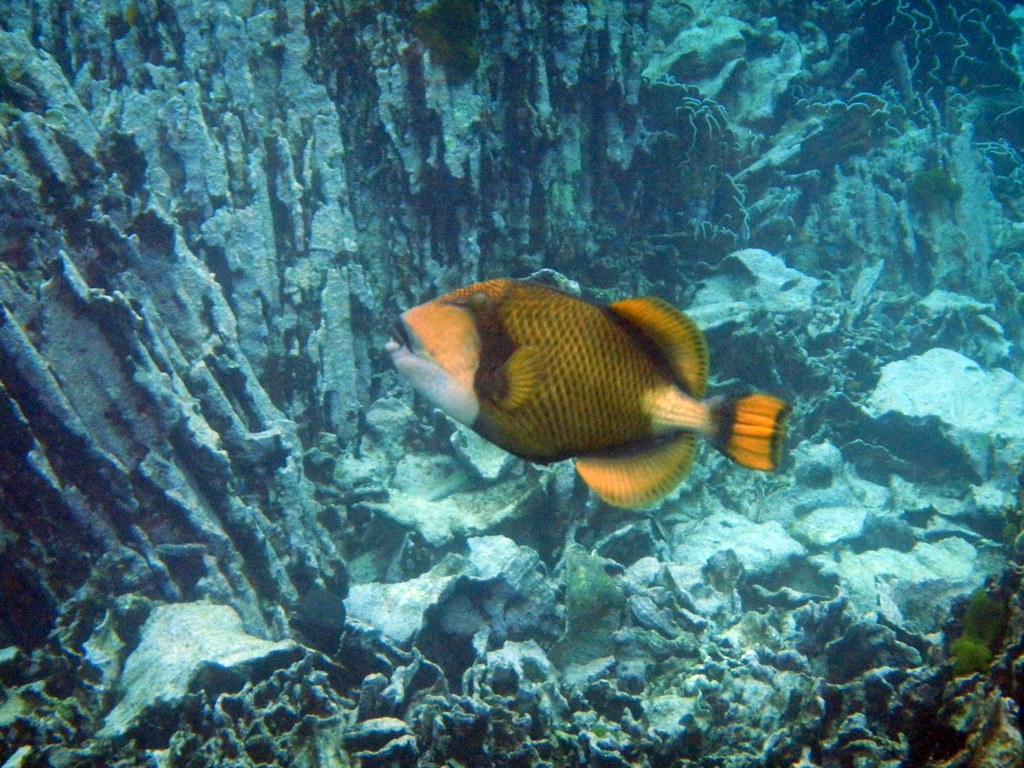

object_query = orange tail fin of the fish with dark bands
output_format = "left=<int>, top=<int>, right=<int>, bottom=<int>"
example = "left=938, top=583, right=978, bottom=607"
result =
left=710, top=394, right=793, bottom=472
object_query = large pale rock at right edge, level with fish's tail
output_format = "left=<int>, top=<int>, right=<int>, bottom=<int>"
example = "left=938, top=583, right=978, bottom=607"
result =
left=864, top=348, right=1024, bottom=483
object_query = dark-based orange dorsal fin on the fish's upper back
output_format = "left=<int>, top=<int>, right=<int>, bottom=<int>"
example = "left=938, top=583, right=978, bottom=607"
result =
left=608, top=296, right=710, bottom=399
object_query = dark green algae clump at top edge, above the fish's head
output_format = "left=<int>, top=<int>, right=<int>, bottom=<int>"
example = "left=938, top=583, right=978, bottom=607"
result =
left=414, top=0, right=480, bottom=84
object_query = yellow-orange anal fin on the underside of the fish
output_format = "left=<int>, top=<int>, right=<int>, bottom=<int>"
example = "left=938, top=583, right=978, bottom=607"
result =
left=575, top=432, right=696, bottom=508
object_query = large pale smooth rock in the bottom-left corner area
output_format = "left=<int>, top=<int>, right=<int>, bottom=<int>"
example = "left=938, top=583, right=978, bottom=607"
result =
left=98, top=603, right=302, bottom=736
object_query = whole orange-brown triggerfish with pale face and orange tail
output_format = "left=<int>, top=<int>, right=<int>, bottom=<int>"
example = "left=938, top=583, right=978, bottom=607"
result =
left=385, top=279, right=792, bottom=508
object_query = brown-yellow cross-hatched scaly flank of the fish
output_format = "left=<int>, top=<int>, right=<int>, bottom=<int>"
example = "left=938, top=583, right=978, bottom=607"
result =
left=471, top=284, right=665, bottom=461
